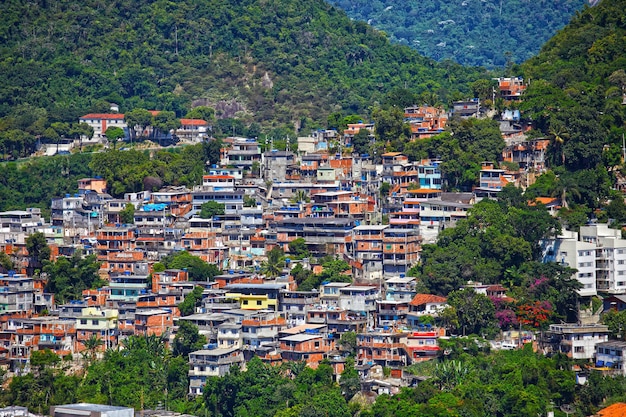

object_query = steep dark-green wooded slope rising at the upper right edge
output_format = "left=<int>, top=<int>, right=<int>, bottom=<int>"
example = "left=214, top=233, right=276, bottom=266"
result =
left=522, top=0, right=626, bottom=171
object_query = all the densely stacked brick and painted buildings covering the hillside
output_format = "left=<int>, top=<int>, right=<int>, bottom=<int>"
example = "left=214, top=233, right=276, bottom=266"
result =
left=0, top=79, right=626, bottom=395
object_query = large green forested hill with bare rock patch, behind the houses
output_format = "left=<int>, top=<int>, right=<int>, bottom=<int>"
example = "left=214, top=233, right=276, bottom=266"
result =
left=0, top=0, right=486, bottom=136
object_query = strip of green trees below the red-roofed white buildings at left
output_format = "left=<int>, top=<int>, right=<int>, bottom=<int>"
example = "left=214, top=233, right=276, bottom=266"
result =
left=0, top=141, right=220, bottom=213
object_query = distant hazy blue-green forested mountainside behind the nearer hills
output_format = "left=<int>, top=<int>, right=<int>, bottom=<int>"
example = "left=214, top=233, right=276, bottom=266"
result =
left=330, top=0, right=585, bottom=68
